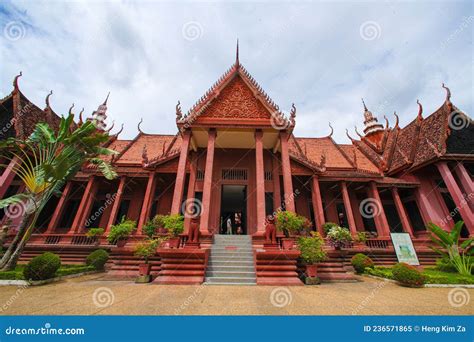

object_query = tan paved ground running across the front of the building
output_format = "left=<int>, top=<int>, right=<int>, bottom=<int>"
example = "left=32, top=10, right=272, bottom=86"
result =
left=0, top=274, right=474, bottom=315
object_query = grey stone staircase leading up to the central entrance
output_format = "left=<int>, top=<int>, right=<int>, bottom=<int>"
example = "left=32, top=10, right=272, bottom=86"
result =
left=205, top=235, right=257, bottom=285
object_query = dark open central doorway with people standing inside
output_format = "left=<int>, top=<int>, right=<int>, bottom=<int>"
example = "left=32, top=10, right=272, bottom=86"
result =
left=219, top=185, right=247, bottom=235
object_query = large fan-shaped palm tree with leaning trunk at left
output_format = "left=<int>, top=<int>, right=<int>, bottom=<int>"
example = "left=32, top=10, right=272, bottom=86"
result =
left=0, top=114, right=117, bottom=270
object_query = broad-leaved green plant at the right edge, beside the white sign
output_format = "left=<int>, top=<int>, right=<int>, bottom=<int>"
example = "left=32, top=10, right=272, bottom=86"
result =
left=427, top=221, right=474, bottom=276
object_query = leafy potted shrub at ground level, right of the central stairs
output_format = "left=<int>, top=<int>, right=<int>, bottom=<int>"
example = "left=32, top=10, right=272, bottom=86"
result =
left=298, top=232, right=327, bottom=278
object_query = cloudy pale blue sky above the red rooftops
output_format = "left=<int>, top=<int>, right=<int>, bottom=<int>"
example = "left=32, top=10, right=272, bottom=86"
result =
left=0, top=0, right=474, bottom=142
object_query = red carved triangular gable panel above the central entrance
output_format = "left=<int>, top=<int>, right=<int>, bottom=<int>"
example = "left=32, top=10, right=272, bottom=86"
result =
left=196, top=74, right=271, bottom=124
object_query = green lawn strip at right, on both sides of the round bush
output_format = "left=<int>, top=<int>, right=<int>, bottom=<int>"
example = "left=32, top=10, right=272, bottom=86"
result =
left=365, top=266, right=474, bottom=284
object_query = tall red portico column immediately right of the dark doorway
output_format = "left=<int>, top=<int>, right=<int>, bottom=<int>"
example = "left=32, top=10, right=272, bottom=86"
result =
left=255, top=130, right=265, bottom=233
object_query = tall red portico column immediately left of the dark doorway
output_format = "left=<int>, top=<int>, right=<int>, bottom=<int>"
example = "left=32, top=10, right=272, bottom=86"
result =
left=199, top=129, right=216, bottom=233
